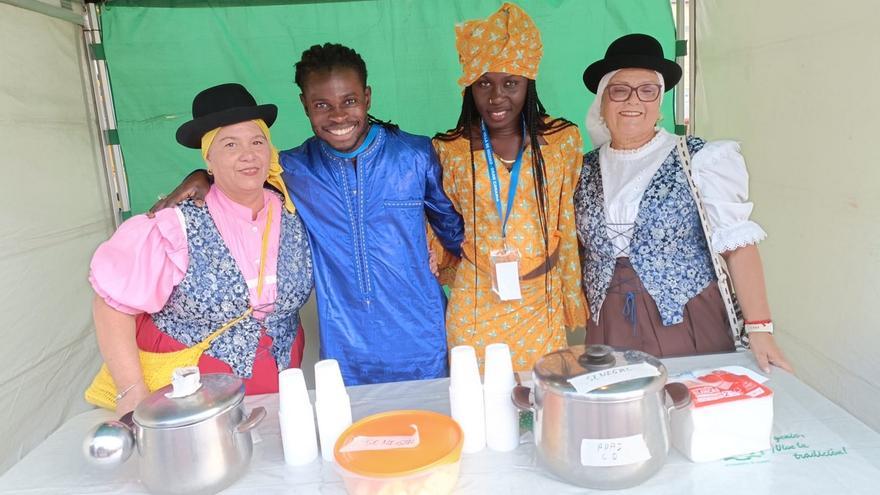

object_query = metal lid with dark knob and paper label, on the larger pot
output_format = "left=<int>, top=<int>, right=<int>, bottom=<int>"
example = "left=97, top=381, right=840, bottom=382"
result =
left=534, top=345, right=667, bottom=401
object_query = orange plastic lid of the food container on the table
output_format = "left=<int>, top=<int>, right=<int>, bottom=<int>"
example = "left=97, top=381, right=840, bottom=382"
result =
left=333, top=410, right=464, bottom=478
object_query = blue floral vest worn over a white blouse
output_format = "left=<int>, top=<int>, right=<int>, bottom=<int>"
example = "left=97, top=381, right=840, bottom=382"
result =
left=575, top=137, right=715, bottom=326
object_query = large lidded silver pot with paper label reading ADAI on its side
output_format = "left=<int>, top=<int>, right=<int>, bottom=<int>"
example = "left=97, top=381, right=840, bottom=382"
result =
left=513, top=345, right=690, bottom=490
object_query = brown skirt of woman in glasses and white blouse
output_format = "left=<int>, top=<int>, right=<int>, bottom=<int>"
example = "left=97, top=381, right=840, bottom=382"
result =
left=586, top=258, right=734, bottom=357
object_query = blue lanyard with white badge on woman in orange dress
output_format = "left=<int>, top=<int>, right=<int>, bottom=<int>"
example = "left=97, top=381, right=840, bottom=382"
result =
left=480, top=120, right=526, bottom=301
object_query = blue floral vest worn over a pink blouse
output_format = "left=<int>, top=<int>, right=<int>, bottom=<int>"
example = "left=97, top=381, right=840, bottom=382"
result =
left=152, top=201, right=312, bottom=378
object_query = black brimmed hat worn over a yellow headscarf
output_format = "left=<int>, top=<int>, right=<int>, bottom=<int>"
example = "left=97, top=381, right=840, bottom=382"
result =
left=177, top=83, right=278, bottom=149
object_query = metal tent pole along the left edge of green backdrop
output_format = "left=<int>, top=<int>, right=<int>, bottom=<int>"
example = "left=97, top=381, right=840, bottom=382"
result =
left=83, top=3, right=131, bottom=227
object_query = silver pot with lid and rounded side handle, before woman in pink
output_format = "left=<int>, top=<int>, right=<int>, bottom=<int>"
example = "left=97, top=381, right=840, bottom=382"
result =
left=85, top=373, right=266, bottom=495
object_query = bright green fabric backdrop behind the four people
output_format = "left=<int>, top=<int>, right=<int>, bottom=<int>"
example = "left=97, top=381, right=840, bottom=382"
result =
left=101, top=0, right=675, bottom=213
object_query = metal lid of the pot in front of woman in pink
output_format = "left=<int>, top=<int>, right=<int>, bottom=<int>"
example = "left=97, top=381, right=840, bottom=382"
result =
left=134, top=373, right=244, bottom=428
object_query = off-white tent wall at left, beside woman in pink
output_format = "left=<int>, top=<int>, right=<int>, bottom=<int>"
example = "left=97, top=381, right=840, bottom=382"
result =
left=0, top=3, right=113, bottom=473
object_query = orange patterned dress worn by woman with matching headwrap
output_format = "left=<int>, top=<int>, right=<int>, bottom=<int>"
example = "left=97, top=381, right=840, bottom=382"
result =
left=428, top=126, right=588, bottom=370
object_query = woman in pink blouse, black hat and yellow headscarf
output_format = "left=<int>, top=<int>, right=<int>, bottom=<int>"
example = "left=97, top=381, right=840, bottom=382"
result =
left=89, top=84, right=312, bottom=412
